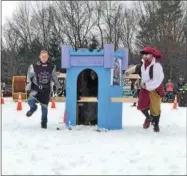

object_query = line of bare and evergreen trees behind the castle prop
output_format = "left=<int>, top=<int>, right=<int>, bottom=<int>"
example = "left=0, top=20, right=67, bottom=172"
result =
left=1, top=1, right=187, bottom=83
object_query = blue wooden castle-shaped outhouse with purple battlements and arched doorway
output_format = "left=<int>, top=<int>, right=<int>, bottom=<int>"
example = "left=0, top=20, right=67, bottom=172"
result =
left=61, top=44, right=128, bottom=130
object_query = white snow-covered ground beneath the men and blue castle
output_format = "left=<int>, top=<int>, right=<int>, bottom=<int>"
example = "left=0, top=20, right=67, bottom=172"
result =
left=2, top=99, right=187, bottom=175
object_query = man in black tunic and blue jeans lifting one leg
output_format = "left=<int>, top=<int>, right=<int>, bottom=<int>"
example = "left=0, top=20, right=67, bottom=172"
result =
left=26, top=50, right=58, bottom=128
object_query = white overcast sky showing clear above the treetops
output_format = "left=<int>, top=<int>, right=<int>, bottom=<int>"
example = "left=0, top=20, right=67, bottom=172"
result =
left=2, top=1, right=133, bottom=25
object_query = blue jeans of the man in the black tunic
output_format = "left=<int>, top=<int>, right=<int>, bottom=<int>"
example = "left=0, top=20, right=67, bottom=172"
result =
left=28, top=99, right=48, bottom=125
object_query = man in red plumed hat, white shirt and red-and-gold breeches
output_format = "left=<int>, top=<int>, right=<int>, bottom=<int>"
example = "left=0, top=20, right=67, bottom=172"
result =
left=126, top=47, right=165, bottom=132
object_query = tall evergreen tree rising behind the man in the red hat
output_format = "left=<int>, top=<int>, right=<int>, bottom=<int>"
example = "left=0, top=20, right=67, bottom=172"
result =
left=136, top=1, right=182, bottom=79
